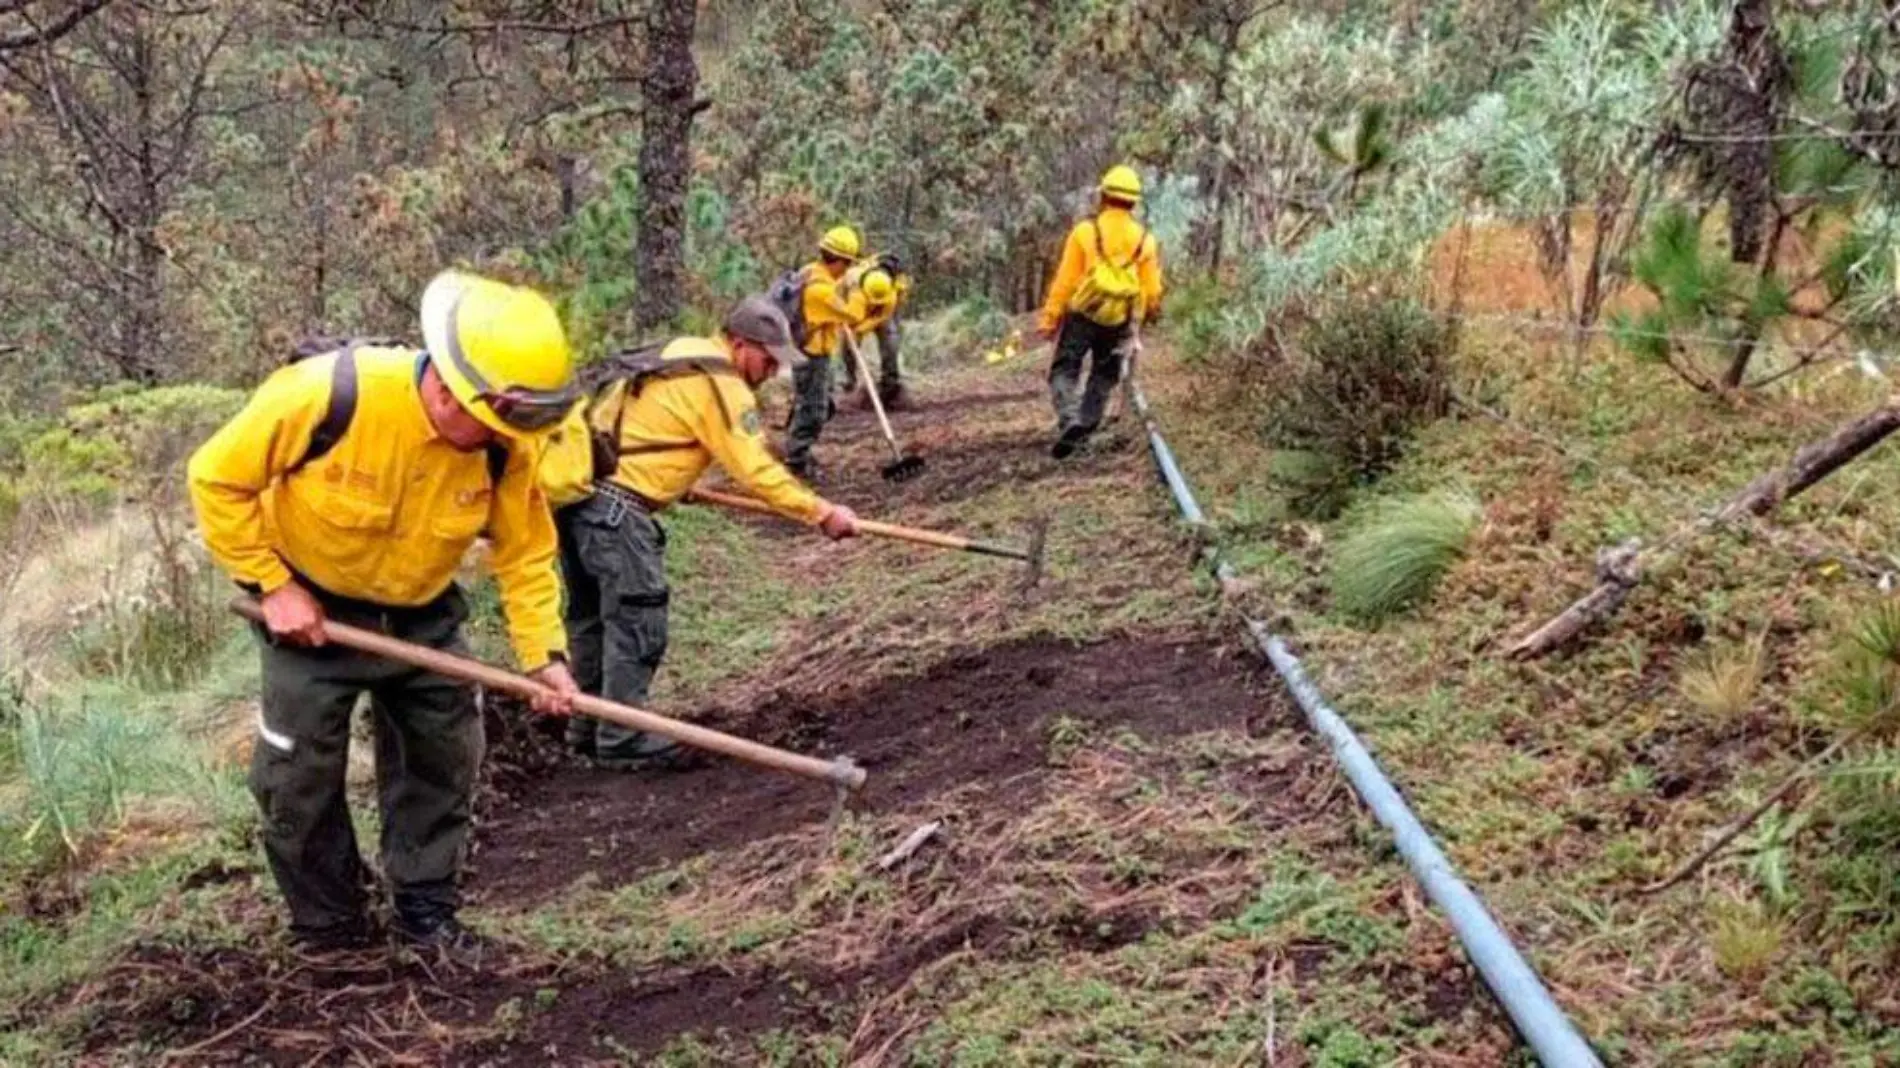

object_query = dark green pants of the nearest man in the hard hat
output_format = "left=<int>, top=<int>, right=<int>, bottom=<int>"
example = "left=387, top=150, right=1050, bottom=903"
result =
left=251, top=587, right=483, bottom=935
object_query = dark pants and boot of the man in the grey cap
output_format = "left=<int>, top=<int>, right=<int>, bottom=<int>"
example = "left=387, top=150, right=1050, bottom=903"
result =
left=555, top=490, right=675, bottom=760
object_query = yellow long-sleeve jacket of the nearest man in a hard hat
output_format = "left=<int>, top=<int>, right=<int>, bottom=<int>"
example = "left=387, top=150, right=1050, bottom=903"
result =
left=188, top=348, right=568, bottom=671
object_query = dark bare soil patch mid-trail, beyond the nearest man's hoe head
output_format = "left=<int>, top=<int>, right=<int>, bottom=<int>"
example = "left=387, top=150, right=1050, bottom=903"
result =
left=469, top=639, right=1267, bottom=906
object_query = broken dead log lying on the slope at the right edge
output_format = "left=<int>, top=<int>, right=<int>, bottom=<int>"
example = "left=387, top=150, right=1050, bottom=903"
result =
left=1505, top=403, right=1900, bottom=659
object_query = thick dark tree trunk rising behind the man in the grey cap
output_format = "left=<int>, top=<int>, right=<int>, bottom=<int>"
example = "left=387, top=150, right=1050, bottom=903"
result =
left=633, top=0, right=699, bottom=331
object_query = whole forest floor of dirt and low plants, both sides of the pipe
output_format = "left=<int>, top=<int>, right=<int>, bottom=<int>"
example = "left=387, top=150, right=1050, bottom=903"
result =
left=11, top=220, right=1900, bottom=1068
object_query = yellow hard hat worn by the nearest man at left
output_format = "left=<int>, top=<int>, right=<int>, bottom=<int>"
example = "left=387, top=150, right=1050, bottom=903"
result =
left=422, top=270, right=580, bottom=437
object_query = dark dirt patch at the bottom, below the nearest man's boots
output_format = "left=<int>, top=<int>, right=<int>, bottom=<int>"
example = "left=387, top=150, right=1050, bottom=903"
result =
left=74, top=934, right=847, bottom=1066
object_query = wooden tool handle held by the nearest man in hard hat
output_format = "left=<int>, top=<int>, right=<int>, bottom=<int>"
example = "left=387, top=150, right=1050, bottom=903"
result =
left=232, top=597, right=865, bottom=791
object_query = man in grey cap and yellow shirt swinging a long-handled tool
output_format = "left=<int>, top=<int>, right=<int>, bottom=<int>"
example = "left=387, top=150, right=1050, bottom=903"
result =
left=542, top=296, right=857, bottom=770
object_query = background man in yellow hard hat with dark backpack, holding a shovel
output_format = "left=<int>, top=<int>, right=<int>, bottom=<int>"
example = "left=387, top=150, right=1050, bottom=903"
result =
left=773, top=226, right=866, bottom=483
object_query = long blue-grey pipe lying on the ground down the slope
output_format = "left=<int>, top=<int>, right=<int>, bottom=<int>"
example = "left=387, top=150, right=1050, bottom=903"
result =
left=1129, top=380, right=1602, bottom=1068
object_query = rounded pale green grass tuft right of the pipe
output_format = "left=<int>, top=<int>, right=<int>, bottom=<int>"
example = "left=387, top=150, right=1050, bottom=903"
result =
left=1332, top=484, right=1480, bottom=623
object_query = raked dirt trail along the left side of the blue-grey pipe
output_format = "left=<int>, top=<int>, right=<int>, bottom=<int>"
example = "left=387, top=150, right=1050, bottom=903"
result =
left=59, top=359, right=1511, bottom=1064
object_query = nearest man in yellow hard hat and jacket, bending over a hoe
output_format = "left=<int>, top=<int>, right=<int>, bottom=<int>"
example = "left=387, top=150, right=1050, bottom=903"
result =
left=190, top=272, right=578, bottom=956
